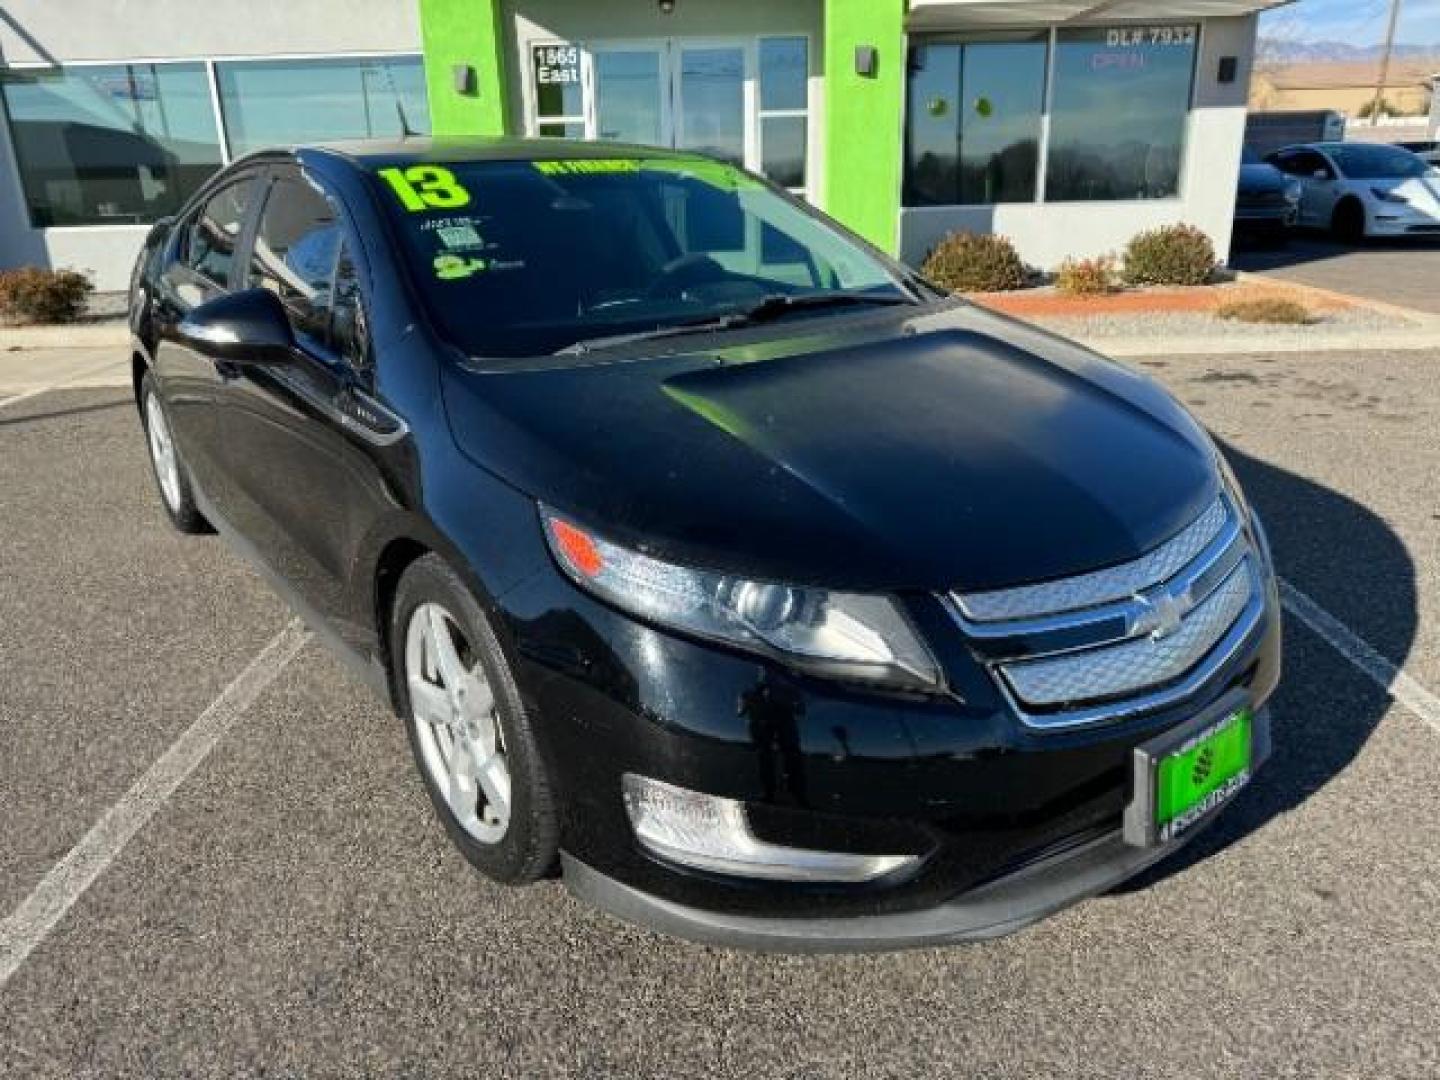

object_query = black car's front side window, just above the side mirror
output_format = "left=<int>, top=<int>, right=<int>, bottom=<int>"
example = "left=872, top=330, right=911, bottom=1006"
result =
left=248, top=173, right=340, bottom=344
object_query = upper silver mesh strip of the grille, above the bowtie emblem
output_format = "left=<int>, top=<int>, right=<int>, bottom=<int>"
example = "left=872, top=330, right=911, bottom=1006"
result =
left=955, top=498, right=1238, bottom=632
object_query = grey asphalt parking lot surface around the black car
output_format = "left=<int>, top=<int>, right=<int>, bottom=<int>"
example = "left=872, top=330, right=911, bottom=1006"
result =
left=0, top=351, right=1440, bottom=1077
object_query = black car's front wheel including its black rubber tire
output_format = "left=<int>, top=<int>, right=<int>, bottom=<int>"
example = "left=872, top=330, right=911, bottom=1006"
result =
left=389, top=554, right=559, bottom=884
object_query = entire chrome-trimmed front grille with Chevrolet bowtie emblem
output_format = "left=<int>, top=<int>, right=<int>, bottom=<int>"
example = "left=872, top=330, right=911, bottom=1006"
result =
left=952, top=498, right=1264, bottom=727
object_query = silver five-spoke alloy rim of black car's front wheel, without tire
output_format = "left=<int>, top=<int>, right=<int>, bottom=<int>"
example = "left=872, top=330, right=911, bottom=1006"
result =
left=405, top=603, right=510, bottom=844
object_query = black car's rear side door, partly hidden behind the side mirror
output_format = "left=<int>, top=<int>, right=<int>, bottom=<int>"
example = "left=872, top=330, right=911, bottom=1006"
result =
left=153, top=168, right=262, bottom=505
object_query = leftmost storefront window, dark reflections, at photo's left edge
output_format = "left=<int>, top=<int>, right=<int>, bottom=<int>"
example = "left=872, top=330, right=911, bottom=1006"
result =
left=0, top=63, right=220, bottom=228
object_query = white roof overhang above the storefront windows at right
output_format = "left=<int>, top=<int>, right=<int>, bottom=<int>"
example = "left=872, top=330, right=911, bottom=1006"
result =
left=906, top=0, right=1292, bottom=30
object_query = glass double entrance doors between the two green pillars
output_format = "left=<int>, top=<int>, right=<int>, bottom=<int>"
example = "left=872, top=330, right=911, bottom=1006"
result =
left=586, top=39, right=759, bottom=168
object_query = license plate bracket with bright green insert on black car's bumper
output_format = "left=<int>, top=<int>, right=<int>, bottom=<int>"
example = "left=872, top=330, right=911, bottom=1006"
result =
left=1125, top=691, right=1270, bottom=847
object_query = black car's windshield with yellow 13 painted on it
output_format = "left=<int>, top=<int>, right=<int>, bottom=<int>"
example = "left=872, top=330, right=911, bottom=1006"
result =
left=376, top=158, right=909, bottom=357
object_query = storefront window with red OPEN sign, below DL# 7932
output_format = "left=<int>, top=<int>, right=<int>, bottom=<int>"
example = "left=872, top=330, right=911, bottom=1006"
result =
left=1045, top=26, right=1198, bottom=202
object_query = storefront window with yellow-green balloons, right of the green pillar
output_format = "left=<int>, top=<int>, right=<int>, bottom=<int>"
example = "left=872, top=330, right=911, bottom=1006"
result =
left=904, top=35, right=1047, bottom=206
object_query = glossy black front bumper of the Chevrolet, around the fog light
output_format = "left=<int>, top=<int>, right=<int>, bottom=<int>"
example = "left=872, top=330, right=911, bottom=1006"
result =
left=501, top=521, right=1280, bottom=950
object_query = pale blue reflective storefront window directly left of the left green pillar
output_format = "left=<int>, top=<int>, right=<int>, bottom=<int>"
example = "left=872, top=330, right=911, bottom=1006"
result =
left=216, top=56, right=431, bottom=157
